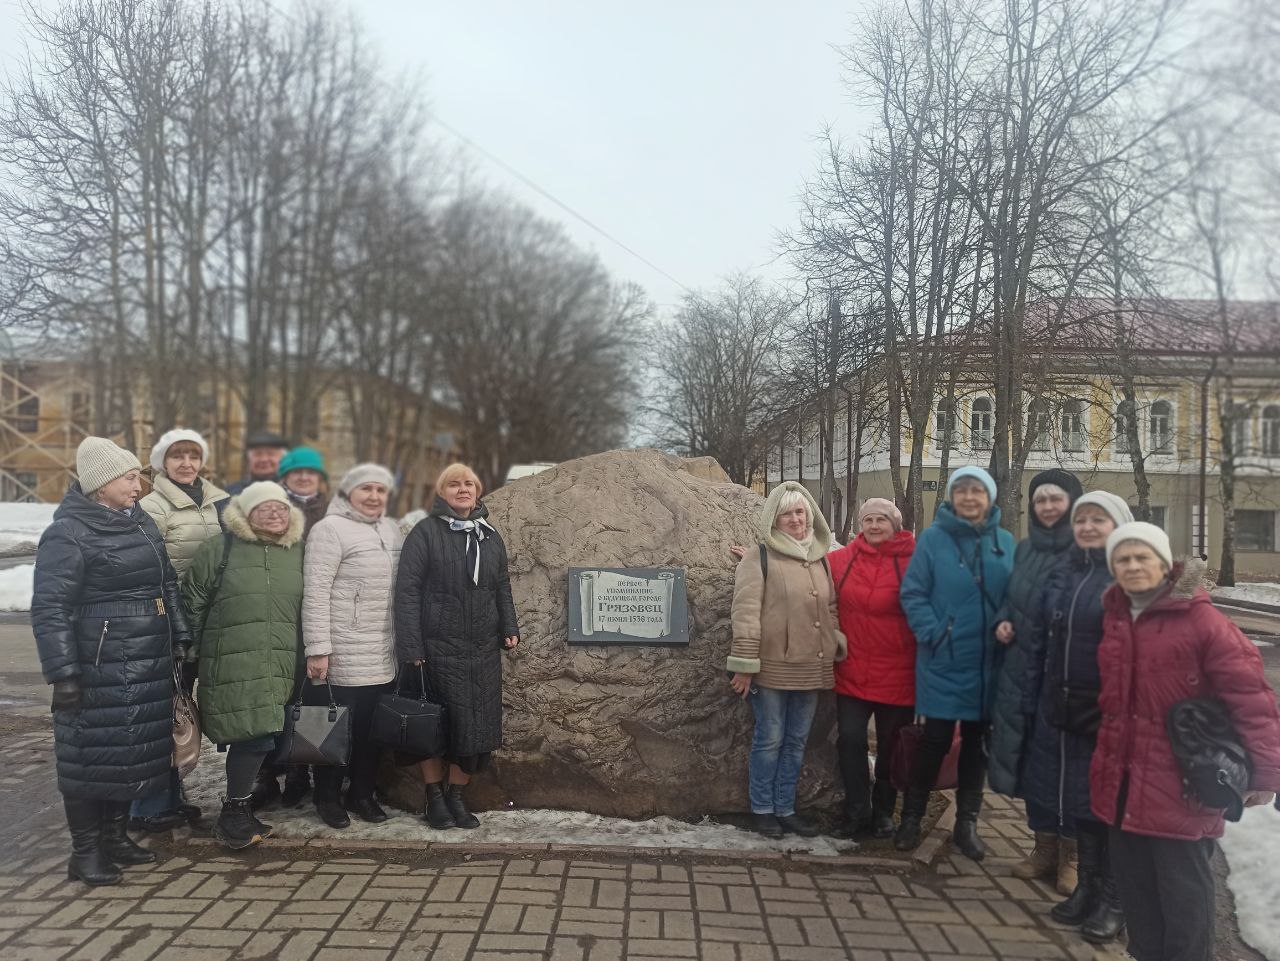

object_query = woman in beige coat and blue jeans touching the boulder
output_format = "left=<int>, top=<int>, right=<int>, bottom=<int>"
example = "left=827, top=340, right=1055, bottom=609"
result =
left=727, top=481, right=846, bottom=837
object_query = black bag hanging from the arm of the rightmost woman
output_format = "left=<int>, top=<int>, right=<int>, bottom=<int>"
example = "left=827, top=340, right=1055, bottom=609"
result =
left=1165, top=697, right=1253, bottom=820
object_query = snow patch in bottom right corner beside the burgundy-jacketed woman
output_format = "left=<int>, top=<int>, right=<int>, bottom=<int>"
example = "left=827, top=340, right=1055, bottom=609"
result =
left=1221, top=805, right=1280, bottom=961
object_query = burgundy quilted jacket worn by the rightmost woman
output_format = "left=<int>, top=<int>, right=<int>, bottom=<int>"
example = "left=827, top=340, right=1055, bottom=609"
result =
left=1089, top=564, right=1280, bottom=841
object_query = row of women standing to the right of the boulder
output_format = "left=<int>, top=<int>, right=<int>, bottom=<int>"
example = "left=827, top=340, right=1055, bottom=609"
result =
left=726, top=466, right=1280, bottom=961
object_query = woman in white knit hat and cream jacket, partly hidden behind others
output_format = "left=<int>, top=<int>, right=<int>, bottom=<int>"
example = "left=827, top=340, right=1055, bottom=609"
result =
left=131, top=427, right=230, bottom=830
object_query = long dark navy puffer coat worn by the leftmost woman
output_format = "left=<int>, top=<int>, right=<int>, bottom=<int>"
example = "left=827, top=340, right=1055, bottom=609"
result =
left=31, top=484, right=191, bottom=801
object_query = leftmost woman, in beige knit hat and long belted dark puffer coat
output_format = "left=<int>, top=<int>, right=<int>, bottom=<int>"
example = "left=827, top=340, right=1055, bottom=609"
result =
left=31, top=438, right=191, bottom=884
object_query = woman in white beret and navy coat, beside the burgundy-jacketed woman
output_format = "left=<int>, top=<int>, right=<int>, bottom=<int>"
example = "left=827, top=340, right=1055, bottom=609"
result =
left=1021, top=491, right=1133, bottom=944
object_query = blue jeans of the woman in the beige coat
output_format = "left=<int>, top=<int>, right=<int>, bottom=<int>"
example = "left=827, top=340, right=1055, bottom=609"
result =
left=748, top=685, right=818, bottom=816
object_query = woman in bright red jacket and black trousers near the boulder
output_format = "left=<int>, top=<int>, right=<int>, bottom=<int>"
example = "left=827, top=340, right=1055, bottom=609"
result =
left=828, top=498, right=915, bottom=838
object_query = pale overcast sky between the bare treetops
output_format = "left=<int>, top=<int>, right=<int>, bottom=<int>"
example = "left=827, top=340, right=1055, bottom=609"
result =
left=0, top=0, right=867, bottom=305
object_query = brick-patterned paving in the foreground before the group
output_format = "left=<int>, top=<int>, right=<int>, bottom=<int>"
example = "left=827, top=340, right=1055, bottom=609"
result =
left=0, top=732, right=1120, bottom=961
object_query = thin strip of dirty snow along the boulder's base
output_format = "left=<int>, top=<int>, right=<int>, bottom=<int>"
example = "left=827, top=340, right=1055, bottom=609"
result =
left=184, top=743, right=858, bottom=855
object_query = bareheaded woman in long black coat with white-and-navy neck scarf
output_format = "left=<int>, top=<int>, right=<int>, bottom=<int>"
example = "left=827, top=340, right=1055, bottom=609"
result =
left=396, top=463, right=520, bottom=828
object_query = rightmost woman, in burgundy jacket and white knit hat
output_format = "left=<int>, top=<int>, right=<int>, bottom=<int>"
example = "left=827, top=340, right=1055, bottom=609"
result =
left=1089, top=522, right=1280, bottom=961
